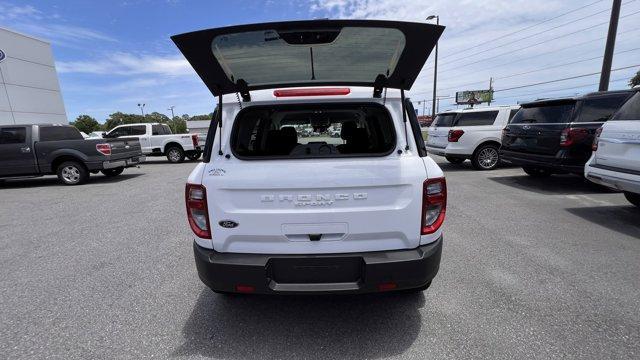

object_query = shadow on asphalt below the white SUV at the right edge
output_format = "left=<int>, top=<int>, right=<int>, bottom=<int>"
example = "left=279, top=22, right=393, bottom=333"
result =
left=566, top=205, right=640, bottom=240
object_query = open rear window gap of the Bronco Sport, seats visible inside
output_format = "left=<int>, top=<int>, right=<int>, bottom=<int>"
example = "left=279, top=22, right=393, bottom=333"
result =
left=231, top=105, right=396, bottom=158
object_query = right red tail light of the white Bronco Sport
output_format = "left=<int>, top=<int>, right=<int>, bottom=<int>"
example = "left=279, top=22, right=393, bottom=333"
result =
left=420, top=178, right=447, bottom=235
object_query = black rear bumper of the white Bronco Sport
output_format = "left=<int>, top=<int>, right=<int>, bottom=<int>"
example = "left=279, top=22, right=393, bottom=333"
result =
left=193, top=237, right=442, bottom=294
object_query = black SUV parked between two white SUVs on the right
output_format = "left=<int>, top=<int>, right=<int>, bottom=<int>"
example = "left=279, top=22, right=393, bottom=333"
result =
left=500, top=89, right=637, bottom=177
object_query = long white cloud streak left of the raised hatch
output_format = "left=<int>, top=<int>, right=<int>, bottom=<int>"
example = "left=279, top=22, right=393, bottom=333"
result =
left=56, top=52, right=195, bottom=76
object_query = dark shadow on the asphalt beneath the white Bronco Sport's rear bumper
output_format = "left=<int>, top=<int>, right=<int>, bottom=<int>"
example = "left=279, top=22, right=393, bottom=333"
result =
left=173, top=289, right=425, bottom=359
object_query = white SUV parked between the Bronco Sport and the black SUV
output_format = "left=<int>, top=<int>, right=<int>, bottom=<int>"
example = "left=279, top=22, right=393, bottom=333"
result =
left=427, top=106, right=520, bottom=170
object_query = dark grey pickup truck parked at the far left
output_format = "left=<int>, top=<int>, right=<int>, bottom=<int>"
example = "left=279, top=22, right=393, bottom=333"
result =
left=0, top=124, right=144, bottom=185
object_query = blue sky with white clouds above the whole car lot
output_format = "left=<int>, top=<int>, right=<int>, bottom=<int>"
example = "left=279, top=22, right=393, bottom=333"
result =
left=0, top=0, right=640, bottom=122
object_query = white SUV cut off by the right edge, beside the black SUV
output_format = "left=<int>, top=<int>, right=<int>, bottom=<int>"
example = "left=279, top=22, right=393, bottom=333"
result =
left=584, top=92, right=640, bottom=207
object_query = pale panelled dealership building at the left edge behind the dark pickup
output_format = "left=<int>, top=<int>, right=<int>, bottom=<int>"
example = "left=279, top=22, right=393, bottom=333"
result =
left=0, top=28, right=68, bottom=125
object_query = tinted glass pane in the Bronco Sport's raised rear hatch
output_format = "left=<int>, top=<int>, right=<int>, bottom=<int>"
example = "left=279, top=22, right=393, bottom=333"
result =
left=211, top=27, right=405, bottom=86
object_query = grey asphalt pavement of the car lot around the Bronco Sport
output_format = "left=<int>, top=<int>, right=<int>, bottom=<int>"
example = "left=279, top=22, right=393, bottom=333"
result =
left=0, top=158, right=640, bottom=359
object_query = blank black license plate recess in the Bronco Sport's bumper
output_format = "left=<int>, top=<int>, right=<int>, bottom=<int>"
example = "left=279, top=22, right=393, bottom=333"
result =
left=267, top=257, right=364, bottom=284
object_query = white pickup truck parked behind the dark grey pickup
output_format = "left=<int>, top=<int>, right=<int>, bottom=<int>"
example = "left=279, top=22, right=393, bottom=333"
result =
left=102, top=123, right=202, bottom=163
